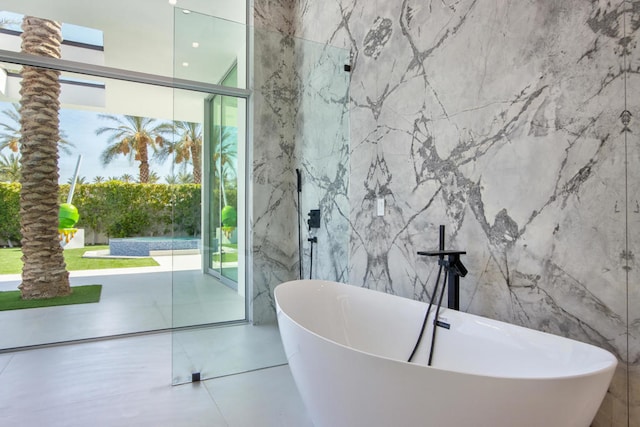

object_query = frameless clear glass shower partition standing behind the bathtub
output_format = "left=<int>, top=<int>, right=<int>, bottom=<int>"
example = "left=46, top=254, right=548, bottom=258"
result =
left=172, top=8, right=349, bottom=384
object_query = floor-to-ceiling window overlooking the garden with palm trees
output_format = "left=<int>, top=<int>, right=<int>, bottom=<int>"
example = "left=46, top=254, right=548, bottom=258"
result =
left=0, top=0, right=249, bottom=356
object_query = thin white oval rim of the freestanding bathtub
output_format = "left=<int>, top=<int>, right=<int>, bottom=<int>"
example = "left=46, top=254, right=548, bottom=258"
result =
left=273, top=279, right=619, bottom=381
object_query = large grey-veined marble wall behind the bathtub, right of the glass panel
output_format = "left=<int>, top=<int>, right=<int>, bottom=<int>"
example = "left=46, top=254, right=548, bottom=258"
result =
left=270, top=0, right=640, bottom=426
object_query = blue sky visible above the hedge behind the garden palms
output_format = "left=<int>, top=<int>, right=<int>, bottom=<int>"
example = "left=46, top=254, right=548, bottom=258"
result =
left=0, top=102, right=180, bottom=184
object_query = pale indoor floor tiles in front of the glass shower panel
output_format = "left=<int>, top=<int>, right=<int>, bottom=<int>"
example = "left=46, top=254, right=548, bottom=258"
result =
left=0, top=333, right=312, bottom=427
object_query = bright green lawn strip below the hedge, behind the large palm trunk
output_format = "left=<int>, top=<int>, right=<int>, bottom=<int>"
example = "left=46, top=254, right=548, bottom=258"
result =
left=0, top=245, right=158, bottom=274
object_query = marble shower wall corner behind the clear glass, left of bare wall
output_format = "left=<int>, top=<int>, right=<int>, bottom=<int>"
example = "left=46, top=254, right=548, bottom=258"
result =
left=251, top=1, right=350, bottom=323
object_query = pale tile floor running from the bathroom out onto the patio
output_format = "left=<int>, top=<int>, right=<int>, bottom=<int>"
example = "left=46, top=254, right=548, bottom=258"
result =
left=0, top=257, right=312, bottom=427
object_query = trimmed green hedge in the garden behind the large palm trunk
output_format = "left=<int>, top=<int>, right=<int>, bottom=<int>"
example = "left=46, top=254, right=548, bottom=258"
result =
left=0, top=181, right=237, bottom=246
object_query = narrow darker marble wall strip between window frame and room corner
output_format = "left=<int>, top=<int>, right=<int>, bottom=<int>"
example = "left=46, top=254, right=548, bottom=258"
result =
left=250, top=28, right=298, bottom=323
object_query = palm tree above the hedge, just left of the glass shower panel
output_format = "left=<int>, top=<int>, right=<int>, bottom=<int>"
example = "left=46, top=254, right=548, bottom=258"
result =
left=96, top=114, right=171, bottom=183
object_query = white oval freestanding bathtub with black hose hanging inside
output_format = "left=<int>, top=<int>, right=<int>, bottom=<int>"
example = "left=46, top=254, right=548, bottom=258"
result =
left=275, top=280, right=617, bottom=427
